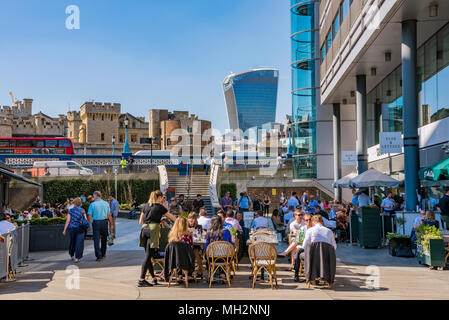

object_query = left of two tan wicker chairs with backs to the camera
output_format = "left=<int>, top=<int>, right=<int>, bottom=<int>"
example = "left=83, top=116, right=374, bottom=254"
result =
left=206, top=241, right=235, bottom=288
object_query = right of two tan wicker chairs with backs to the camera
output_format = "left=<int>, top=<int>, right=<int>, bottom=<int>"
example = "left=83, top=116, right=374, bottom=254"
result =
left=248, top=242, right=278, bottom=290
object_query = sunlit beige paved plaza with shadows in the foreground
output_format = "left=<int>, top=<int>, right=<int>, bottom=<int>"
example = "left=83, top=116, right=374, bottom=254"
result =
left=0, top=219, right=449, bottom=300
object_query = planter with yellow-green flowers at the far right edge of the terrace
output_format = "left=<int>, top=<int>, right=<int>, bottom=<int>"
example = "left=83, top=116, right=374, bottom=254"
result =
left=416, top=224, right=444, bottom=270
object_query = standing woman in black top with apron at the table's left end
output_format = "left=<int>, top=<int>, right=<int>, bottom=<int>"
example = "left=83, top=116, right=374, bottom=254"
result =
left=138, top=190, right=176, bottom=287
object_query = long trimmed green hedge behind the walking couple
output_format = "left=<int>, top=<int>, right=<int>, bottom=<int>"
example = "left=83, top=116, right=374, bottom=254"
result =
left=42, top=179, right=159, bottom=204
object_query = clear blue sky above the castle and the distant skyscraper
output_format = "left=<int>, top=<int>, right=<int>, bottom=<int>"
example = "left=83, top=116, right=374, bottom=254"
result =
left=0, top=0, right=291, bottom=130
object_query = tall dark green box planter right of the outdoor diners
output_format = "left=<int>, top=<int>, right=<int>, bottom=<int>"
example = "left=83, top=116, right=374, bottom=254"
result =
left=358, top=207, right=382, bottom=248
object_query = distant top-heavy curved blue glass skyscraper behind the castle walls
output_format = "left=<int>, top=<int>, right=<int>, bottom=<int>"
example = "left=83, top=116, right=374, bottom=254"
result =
left=223, top=68, right=279, bottom=133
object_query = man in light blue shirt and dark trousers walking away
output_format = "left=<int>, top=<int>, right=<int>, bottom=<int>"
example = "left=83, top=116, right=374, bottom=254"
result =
left=87, top=191, right=114, bottom=261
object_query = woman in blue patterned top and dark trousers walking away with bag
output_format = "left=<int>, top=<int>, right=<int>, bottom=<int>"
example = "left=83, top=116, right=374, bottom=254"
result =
left=62, top=198, right=89, bottom=263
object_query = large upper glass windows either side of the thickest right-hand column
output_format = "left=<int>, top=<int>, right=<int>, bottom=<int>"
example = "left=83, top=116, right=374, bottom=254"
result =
left=367, top=24, right=449, bottom=147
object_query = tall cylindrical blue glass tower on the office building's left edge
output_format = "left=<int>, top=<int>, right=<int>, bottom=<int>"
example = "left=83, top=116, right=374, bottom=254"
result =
left=290, top=0, right=319, bottom=179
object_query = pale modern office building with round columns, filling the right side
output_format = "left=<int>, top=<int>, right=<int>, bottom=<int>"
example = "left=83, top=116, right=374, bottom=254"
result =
left=291, top=0, right=449, bottom=210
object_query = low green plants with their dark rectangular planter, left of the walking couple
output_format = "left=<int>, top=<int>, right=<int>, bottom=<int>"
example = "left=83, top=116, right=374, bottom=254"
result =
left=16, top=218, right=70, bottom=252
